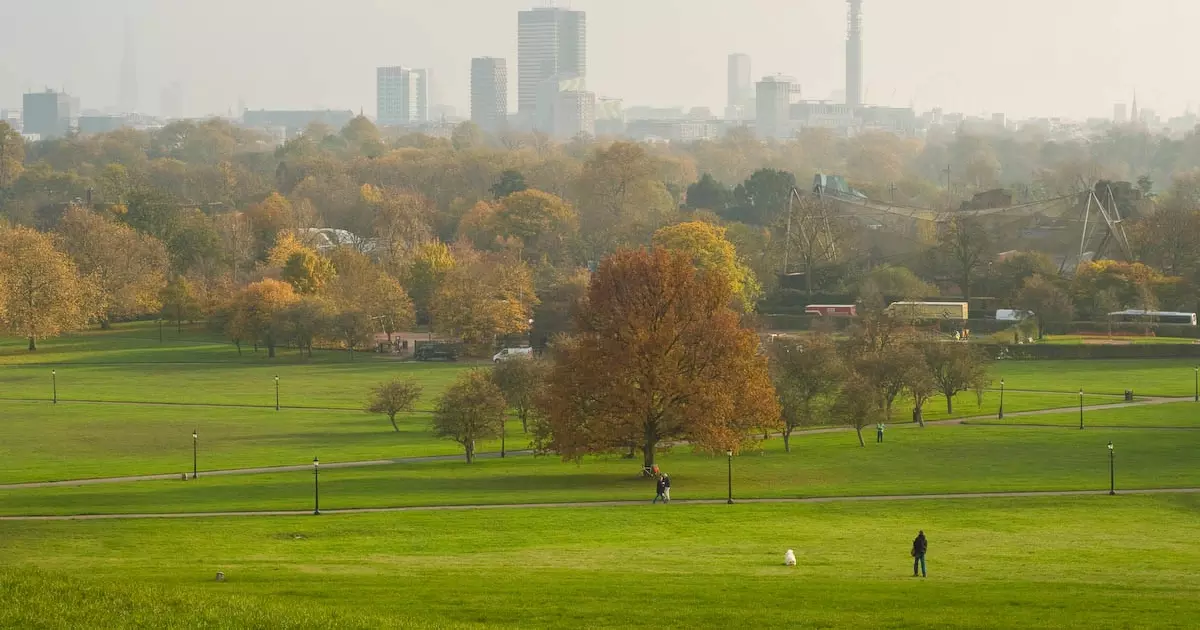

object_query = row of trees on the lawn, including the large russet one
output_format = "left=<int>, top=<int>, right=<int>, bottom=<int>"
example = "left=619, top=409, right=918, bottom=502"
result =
left=379, top=247, right=990, bottom=467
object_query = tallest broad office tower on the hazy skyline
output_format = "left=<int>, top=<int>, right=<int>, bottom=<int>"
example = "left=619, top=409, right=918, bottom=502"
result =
left=517, top=7, right=588, bottom=116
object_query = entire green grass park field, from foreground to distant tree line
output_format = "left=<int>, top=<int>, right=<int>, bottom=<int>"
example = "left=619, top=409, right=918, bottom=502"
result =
left=0, top=324, right=1200, bottom=628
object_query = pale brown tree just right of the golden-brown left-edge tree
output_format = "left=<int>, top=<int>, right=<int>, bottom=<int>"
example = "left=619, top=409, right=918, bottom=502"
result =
left=58, top=208, right=168, bottom=328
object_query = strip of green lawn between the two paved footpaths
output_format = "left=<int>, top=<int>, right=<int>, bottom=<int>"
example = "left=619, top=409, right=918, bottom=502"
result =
left=0, top=426, right=1200, bottom=515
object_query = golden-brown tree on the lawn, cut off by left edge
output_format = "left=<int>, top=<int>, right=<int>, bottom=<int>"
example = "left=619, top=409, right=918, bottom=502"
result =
left=0, top=227, right=96, bottom=352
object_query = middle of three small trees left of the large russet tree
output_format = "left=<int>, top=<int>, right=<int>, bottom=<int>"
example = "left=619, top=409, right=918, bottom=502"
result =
left=433, top=370, right=508, bottom=463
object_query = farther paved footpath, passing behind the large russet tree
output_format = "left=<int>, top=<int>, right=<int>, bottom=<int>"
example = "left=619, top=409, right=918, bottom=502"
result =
left=0, top=397, right=1192, bottom=490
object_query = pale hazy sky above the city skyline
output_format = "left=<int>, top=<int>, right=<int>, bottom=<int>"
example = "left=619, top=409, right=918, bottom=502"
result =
left=0, top=0, right=1200, bottom=118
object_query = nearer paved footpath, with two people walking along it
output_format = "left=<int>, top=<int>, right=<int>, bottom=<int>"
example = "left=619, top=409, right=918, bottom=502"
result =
left=0, top=488, right=1200, bottom=522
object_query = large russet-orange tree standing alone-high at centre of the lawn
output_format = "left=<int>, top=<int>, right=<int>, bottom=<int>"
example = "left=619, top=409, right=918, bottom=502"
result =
left=542, top=248, right=780, bottom=466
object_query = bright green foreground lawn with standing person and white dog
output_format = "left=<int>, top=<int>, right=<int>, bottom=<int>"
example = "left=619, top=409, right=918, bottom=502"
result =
left=0, top=496, right=1200, bottom=629
